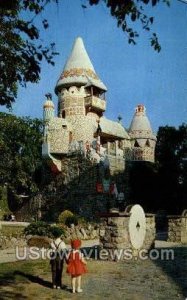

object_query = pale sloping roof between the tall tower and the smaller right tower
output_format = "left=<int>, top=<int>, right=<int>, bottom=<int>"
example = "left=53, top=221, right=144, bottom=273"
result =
left=99, top=117, right=130, bottom=139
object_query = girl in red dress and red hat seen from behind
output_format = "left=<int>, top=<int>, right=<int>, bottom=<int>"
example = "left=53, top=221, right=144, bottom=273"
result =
left=67, top=240, right=86, bottom=293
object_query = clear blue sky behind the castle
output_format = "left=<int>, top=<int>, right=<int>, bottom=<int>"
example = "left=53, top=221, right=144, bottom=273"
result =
left=0, top=0, right=187, bottom=132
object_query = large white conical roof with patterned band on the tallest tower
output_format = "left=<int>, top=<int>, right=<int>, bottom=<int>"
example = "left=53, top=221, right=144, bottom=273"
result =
left=55, top=37, right=107, bottom=93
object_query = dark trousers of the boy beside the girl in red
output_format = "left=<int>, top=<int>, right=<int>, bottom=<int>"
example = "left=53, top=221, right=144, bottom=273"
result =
left=51, top=257, right=63, bottom=287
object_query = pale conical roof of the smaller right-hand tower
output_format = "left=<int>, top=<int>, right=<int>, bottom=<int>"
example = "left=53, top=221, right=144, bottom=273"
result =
left=129, top=104, right=156, bottom=142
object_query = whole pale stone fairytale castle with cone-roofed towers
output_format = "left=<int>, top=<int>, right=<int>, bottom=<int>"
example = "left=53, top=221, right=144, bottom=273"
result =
left=42, top=37, right=156, bottom=178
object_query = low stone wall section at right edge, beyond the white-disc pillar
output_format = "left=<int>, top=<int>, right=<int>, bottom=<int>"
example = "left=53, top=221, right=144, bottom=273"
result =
left=168, top=215, right=187, bottom=244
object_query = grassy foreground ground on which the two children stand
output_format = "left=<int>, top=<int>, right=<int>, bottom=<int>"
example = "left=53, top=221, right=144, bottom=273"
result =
left=0, top=248, right=187, bottom=300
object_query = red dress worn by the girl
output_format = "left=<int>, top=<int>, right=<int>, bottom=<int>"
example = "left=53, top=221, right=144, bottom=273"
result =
left=67, top=250, right=87, bottom=276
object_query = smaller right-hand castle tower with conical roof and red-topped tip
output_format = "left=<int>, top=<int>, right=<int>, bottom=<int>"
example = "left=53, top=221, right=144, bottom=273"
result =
left=129, top=104, right=156, bottom=162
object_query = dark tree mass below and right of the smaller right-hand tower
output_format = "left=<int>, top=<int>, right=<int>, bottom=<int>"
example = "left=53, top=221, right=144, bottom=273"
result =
left=129, top=124, right=187, bottom=214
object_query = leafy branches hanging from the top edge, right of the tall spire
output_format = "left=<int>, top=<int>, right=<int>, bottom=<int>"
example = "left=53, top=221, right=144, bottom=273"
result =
left=87, top=0, right=170, bottom=52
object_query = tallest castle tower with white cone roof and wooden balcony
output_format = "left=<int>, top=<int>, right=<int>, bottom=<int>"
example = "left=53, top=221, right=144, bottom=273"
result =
left=55, top=37, right=107, bottom=142
